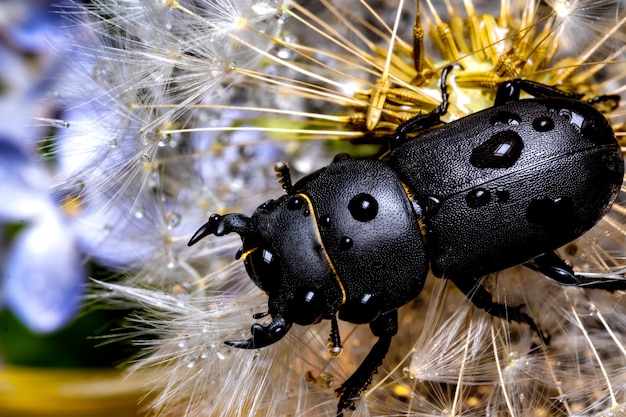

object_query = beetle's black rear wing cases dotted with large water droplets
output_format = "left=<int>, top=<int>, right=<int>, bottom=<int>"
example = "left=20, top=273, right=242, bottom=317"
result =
left=391, top=98, right=624, bottom=278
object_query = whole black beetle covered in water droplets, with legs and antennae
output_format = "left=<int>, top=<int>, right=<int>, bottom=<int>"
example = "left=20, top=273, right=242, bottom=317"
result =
left=189, top=67, right=624, bottom=416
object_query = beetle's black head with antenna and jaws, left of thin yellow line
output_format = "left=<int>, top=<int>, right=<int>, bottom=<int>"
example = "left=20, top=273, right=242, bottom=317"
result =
left=189, top=189, right=342, bottom=348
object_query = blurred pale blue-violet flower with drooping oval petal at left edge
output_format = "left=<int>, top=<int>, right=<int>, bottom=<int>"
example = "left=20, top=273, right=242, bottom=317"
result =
left=0, top=137, right=87, bottom=333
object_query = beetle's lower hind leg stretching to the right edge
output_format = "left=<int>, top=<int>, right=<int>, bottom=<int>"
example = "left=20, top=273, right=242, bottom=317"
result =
left=524, top=252, right=626, bottom=291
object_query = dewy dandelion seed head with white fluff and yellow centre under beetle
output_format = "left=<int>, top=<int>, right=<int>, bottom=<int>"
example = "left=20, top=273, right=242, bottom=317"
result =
left=52, top=0, right=626, bottom=416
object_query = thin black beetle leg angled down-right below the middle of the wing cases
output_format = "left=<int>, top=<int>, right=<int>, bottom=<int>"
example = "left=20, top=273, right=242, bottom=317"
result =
left=452, top=278, right=550, bottom=345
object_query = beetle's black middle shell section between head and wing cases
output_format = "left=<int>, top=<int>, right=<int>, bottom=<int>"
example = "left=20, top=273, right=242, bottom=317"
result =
left=292, top=159, right=428, bottom=323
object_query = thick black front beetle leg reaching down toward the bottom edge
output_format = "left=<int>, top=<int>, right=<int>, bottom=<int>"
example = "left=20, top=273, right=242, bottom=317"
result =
left=335, top=310, right=398, bottom=417
